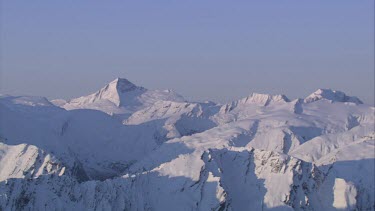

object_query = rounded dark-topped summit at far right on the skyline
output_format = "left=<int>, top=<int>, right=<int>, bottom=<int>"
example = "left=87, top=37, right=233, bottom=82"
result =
left=304, top=89, right=363, bottom=104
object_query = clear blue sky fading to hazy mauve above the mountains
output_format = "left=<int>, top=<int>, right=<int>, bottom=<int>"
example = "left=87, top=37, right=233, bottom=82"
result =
left=0, top=0, right=374, bottom=104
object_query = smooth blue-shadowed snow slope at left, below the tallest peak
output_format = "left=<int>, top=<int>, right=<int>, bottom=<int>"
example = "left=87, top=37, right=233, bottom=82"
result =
left=0, top=97, right=170, bottom=179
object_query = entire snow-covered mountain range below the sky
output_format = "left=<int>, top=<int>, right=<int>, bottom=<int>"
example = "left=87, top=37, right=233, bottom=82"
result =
left=0, top=79, right=375, bottom=211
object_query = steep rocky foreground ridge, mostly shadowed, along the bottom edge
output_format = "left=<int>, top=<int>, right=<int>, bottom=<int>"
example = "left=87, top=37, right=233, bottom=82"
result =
left=0, top=149, right=374, bottom=210
